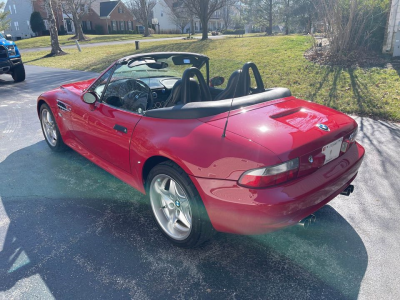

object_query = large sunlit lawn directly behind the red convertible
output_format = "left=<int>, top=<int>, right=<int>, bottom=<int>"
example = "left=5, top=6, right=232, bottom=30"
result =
left=23, top=36, right=400, bottom=122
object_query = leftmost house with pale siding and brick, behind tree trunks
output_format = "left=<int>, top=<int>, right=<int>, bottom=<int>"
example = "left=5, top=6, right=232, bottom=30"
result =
left=4, top=0, right=137, bottom=40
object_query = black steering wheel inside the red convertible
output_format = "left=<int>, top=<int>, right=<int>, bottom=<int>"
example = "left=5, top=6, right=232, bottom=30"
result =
left=122, top=79, right=153, bottom=113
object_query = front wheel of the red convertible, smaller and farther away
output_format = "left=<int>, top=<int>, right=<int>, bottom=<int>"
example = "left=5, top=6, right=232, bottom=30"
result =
left=40, top=104, right=67, bottom=152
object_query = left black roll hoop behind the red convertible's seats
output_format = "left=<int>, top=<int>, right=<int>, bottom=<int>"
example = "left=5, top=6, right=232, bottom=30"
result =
left=181, top=67, right=212, bottom=104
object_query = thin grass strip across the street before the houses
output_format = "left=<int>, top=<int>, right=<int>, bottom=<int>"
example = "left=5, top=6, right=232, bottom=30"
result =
left=15, top=34, right=186, bottom=49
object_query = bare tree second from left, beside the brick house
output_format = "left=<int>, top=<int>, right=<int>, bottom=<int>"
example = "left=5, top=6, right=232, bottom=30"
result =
left=61, top=0, right=96, bottom=41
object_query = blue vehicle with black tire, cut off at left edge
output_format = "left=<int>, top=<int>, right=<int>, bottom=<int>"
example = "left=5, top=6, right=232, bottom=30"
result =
left=0, top=33, right=25, bottom=82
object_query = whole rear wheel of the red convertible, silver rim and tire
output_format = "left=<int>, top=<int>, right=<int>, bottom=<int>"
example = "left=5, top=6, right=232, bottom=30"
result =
left=147, top=162, right=214, bottom=248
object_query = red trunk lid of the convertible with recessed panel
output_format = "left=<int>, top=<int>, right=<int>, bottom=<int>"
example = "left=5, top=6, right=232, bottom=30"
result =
left=208, top=97, right=357, bottom=161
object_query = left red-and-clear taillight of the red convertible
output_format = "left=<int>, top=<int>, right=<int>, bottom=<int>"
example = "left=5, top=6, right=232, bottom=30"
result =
left=238, top=158, right=299, bottom=188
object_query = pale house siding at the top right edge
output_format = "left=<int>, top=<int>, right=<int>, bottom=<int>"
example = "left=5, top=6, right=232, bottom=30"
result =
left=383, top=0, right=400, bottom=56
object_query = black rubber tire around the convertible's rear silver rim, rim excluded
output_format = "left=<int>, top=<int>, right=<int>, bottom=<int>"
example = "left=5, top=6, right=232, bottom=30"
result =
left=146, top=161, right=215, bottom=248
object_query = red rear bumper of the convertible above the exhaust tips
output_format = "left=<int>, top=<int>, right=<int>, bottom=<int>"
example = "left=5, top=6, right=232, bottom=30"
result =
left=192, top=143, right=365, bottom=234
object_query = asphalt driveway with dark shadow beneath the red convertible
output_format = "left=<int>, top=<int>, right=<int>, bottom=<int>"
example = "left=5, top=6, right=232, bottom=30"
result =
left=0, top=66, right=400, bottom=299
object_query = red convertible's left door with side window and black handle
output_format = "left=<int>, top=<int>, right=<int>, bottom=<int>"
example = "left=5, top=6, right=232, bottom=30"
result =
left=73, top=67, right=148, bottom=172
